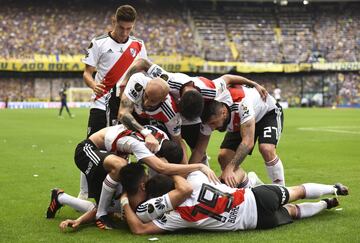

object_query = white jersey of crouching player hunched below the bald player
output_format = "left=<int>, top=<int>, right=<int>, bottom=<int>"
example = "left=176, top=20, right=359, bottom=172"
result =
left=105, top=124, right=169, bottom=160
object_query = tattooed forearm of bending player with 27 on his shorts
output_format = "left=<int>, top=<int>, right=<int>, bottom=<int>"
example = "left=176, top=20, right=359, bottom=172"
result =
left=230, top=118, right=255, bottom=169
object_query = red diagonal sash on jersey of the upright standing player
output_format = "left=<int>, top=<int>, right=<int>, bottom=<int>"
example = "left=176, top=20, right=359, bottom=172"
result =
left=95, top=41, right=142, bottom=100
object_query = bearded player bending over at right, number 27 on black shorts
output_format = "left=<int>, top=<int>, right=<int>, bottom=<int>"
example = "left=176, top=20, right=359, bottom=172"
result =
left=196, top=83, right=285, bottom=187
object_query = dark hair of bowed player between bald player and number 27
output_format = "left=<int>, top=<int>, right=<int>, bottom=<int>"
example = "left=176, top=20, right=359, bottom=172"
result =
left=179, top=90, right=204, bottom=121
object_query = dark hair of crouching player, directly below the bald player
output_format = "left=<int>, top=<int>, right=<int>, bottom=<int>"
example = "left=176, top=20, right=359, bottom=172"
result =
left=156, top=140, right=184, bottom=164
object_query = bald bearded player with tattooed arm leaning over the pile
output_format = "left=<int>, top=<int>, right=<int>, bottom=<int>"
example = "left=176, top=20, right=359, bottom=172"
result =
left=119, top=73, right=187, bottom=164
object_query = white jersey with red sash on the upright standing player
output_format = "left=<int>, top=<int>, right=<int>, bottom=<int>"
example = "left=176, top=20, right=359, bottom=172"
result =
left=82, top=34, right=147, bottom=110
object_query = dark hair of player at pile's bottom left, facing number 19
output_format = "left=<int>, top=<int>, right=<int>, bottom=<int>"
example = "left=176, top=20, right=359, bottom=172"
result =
left=119, top=163, right=146, bottom=195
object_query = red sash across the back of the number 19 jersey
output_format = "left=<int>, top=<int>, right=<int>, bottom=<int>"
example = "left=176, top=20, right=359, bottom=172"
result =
left=176, top=189, right=245, bottom=222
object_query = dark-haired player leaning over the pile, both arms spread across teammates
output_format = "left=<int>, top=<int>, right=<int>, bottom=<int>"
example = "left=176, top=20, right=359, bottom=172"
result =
left=119, top=58, right=267, bottom=167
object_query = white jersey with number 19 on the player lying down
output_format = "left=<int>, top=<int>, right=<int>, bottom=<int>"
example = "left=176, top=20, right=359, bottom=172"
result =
left=152, top=171, right=257, bottom=231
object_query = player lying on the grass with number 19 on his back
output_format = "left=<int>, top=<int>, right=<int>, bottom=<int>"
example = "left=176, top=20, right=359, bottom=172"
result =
left=121, top=164, right=348, bottom=234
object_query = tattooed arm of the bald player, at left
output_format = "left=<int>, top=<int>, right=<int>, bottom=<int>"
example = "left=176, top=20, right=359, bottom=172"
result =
left=118, top=95, right=144, bottom=131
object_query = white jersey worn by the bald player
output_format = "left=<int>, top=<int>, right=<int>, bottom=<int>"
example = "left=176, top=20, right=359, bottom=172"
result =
left=124, top=73, right=182, bottom=136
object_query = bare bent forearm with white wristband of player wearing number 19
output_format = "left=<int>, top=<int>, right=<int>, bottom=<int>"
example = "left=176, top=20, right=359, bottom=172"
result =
left=120, top=193, right=165, bottom=235
